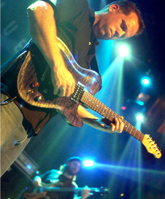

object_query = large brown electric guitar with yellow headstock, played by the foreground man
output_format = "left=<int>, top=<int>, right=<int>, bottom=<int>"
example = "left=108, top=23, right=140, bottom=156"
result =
left=17, top=39, right=161, bottom=158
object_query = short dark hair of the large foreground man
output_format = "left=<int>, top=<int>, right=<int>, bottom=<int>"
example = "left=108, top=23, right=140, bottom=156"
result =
left=102, top=1, right=145, bottom=35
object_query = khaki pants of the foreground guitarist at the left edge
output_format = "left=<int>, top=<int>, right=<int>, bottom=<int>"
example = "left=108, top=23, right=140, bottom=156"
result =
left=0, top=94, right=30, bottom=176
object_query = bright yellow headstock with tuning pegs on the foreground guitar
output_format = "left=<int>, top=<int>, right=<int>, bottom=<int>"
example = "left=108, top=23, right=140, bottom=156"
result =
left=142, top=134, right=162, bottom=158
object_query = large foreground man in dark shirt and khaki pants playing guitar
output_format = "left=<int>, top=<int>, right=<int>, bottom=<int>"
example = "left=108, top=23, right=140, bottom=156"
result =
left=1, top=0, right=144, bottom=175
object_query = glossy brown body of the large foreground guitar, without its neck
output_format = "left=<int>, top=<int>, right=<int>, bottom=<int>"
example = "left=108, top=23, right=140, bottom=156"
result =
left=17, top=39, right=101, bottom=127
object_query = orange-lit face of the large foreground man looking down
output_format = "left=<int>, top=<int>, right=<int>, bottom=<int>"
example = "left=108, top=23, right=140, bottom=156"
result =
left=94, top=4, right=139, bottom=40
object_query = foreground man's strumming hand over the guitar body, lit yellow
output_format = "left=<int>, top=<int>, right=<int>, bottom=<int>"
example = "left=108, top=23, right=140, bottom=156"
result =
left=51, top=65, right=75, bottom=97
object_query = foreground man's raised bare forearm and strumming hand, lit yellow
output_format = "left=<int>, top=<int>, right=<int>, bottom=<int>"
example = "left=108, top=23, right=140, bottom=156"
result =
left=27, top=1, right=75, bottom=96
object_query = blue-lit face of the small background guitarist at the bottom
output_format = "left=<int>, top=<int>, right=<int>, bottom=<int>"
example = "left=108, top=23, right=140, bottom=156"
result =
left=67, top=160, right=81, bottom=175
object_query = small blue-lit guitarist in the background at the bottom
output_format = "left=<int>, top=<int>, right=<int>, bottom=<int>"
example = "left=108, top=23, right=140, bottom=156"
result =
left=19, top=156, right=91, bottom=199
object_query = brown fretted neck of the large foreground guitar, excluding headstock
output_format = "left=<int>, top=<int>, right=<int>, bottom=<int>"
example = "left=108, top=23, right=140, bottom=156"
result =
left=81, top=91, right=144, bottom=142
